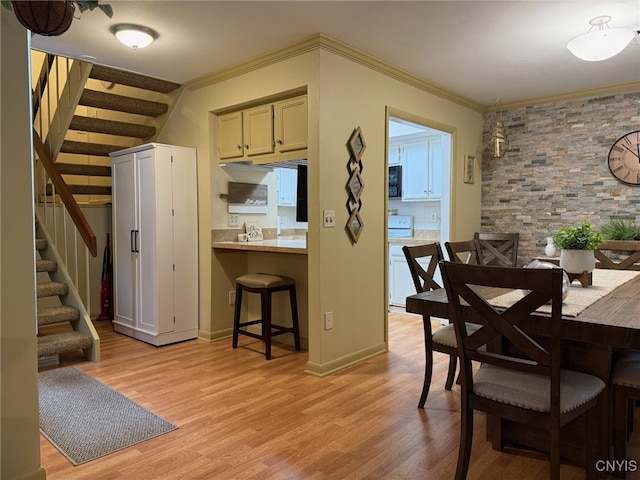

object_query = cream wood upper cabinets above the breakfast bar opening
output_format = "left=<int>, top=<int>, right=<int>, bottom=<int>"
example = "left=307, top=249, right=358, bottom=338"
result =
left=218, top=96, right=307, bottom=163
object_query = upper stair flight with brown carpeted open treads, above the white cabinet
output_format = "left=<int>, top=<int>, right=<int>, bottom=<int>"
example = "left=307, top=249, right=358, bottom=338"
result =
left=46, top=61, right=180, bottom=203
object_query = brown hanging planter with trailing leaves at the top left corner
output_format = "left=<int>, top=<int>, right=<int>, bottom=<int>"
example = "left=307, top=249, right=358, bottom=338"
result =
left=0, top=0, right=113, bottom=36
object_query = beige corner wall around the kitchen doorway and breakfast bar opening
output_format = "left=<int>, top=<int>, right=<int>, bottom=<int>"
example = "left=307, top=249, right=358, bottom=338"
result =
left=161, top=39, right=482, bottom=375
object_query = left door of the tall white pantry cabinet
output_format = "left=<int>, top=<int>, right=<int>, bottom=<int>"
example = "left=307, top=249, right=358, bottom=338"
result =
left=112, top=153, right=138, bottom=327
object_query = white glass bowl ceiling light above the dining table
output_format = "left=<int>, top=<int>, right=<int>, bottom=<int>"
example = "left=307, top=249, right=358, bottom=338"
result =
left=567, top=15, right=636, bottom=62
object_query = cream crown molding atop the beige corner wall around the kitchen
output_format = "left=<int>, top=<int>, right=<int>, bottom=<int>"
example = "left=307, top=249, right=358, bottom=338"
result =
left=184, top=33, right=483, bottom=112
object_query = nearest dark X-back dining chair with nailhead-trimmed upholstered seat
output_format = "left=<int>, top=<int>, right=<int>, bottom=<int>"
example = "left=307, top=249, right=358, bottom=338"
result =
left=440, top=262, right=605, bottom=480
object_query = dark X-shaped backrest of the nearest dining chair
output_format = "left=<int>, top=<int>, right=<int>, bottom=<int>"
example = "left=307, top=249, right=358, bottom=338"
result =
left=440, top=262, right=562, bottom=386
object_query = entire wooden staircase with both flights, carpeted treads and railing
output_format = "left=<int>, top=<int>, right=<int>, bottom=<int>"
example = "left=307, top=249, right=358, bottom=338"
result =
left=34, top=54, right=180, bottom=366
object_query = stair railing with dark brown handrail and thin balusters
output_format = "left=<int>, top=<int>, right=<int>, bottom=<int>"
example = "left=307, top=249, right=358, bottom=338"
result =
left=32, top=52, right=97, bottom=318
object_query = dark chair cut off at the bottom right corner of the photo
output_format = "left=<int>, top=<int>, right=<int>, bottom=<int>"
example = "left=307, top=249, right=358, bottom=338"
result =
left=611, top=350, right=640, bottom=478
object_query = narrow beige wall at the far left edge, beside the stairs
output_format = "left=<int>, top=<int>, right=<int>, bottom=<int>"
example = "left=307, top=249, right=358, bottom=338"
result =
left=0, top=8, right=45, bottom=480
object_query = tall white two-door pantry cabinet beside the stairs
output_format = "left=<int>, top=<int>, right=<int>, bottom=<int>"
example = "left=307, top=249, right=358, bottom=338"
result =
left=110, top=143, right=198, bottom=345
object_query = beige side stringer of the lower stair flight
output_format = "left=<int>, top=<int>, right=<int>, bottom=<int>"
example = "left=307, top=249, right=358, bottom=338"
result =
left=35, top=205, right=100, bottom=362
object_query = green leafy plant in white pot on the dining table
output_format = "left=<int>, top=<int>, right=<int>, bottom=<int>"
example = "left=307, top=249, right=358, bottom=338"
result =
left=552, top=220, right=604, bottom=274
